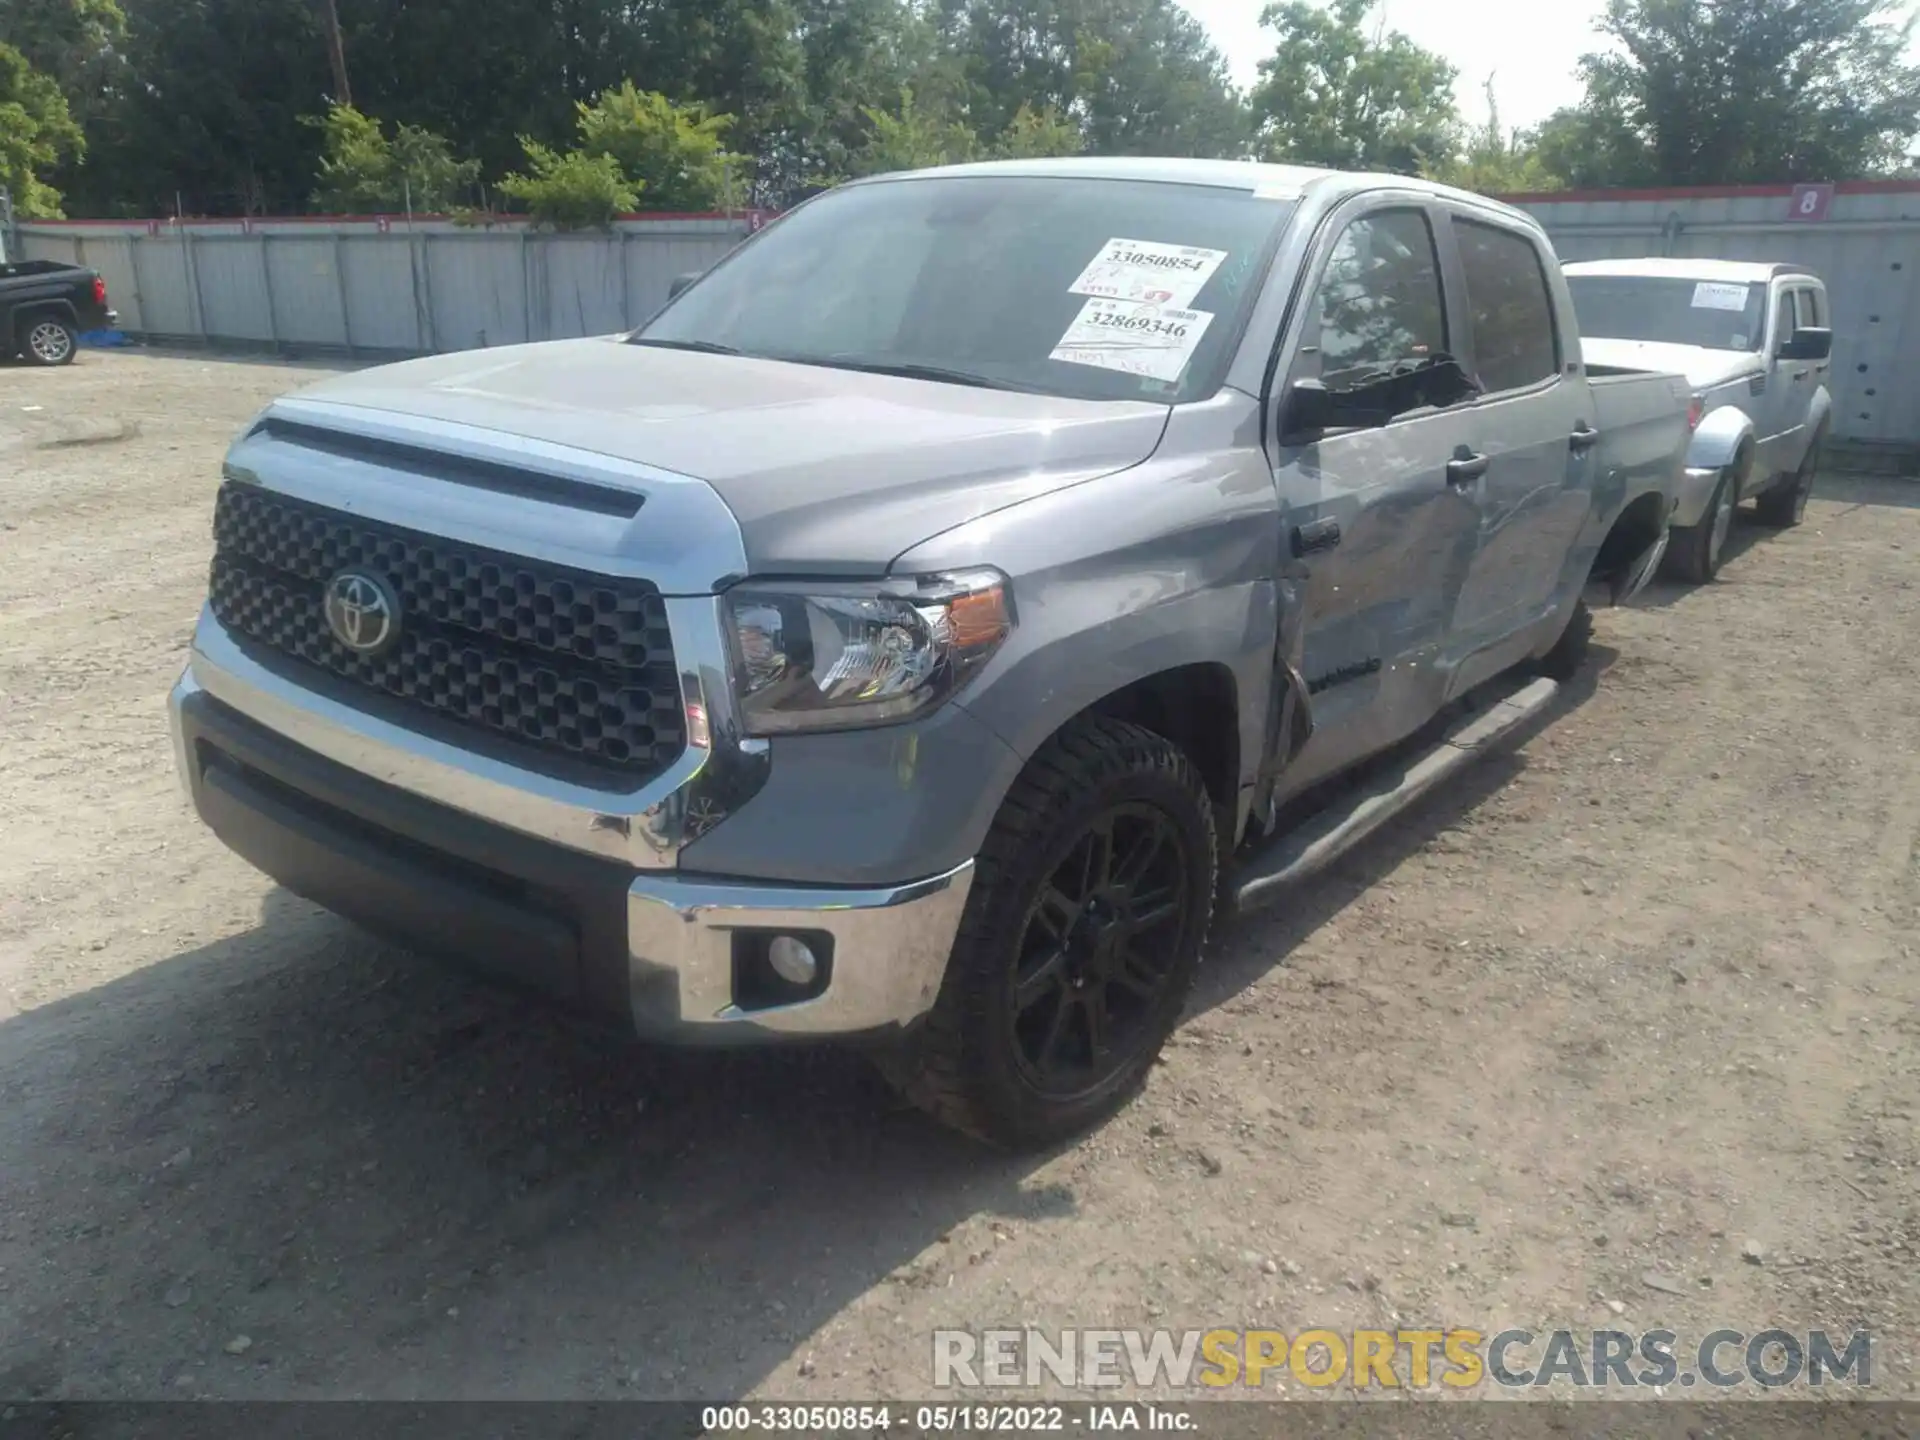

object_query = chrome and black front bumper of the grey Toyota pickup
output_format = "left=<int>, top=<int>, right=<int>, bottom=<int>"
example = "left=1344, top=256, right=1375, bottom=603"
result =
left=169, top=641, right=973, bottom=1044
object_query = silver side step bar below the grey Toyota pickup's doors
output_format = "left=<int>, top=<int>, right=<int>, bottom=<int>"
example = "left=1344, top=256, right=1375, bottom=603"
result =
left=1235, top=680, right=1559, bottom=910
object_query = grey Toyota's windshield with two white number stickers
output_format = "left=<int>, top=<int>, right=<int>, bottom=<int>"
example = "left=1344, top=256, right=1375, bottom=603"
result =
left=632, top=175, right=1292, bottom=403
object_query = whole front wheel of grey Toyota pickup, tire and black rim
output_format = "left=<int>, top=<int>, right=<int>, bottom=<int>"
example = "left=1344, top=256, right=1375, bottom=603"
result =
left=876, top=720, right=1219, bottom=1148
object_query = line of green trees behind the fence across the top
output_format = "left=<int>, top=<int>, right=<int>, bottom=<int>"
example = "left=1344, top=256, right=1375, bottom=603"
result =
left=26, top=0, right=1920, bottom=215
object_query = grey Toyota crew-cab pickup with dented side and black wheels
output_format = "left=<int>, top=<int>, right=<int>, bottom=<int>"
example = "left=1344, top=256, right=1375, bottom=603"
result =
left=173, top=159, right=1688, bottom=1144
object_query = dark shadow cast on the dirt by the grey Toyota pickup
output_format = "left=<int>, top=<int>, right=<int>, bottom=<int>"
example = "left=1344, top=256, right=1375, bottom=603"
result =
left=0, top=647, right=1613, bottom=1400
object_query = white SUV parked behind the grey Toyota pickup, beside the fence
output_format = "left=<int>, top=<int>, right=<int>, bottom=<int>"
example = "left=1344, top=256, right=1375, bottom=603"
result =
left=1563, top=259, right=1834, bottom=584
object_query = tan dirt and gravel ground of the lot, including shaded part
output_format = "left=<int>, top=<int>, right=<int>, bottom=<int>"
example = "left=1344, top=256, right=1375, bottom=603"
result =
left=0, top=353, right=1920, bottom=1400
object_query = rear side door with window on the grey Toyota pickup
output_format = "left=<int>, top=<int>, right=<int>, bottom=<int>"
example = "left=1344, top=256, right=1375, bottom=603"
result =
left=1448, top=207, right=1597, bottom=656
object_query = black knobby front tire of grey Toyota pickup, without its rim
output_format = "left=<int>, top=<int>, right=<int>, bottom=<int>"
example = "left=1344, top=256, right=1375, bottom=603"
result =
left=874, top=718, right=1219, bottom=1150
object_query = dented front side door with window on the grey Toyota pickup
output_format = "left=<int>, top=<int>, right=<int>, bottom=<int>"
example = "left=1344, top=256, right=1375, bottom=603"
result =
left=1269, top=196, right=1480, bottom=789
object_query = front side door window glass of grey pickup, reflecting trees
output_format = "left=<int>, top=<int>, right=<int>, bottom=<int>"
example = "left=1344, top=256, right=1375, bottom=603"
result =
left=1294, top=209, right=1446, bottom=390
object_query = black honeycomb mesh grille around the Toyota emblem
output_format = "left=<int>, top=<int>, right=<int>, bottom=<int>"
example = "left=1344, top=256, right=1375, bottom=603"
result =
left=207, top=482, right=685, bottom=780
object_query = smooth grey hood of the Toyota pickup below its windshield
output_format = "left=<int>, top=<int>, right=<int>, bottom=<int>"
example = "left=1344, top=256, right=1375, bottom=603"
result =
left=284, top=336, right=1167, bottom=574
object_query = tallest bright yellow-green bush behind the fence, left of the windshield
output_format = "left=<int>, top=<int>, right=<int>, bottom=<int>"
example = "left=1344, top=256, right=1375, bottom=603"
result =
left=580, top=81, right=751, bottom=211
